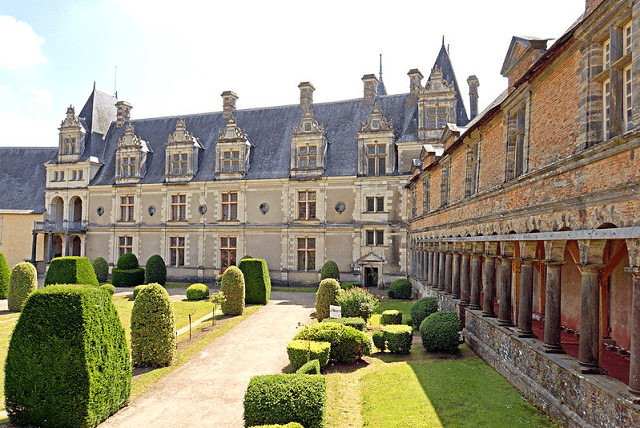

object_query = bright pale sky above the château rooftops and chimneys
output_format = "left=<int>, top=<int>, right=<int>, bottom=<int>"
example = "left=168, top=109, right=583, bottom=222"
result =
left=0, top=0, right=585, bottom=146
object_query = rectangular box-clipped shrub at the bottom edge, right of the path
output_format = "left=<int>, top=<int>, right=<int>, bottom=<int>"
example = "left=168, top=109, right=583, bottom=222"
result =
left=244, top=374, right=327, bottom=428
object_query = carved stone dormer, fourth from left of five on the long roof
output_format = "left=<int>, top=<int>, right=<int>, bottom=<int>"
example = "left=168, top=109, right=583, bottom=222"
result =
left=291, top=109, right=328, bottom=179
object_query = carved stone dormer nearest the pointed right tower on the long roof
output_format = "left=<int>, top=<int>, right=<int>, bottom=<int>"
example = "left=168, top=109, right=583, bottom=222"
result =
left=358, top=104, right=396, bottom=176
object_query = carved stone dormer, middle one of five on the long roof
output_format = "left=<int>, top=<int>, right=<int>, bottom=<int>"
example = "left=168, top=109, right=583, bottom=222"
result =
left=216, top=114, right=251, bottom=179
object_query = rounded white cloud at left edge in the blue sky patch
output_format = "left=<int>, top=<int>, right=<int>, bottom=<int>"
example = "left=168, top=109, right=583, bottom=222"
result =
left=0, top=15, right=45, bottom=70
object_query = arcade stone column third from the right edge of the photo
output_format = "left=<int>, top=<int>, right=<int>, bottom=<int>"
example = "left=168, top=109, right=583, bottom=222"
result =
left=544, top=261, right=564, bottom=354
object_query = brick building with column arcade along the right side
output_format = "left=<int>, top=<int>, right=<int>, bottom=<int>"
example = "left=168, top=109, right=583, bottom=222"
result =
left=407, top=0, right=640, bottom=427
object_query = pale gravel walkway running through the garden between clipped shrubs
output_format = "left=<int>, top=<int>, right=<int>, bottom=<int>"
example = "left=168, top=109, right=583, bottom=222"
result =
left=100, top=292, right=315, bottom=428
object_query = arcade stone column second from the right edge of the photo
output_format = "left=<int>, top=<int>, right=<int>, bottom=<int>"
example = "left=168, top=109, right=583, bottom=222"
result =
left=578, top=264, right=603, bottom=369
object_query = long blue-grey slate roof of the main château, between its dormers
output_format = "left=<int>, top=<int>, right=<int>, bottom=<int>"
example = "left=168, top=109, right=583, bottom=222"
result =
left=91, top=94, right=417, bottom=185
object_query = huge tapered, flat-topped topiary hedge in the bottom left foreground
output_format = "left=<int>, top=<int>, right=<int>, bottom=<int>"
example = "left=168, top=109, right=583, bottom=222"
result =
left=4, top=285, right=131, bottom=427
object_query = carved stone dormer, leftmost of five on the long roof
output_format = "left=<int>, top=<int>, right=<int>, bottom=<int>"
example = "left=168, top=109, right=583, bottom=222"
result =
left=115, top=124, right=151, bottom=184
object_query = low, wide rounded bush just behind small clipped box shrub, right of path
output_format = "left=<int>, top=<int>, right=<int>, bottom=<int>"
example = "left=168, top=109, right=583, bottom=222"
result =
left=293, top=322, right=371, bottom=363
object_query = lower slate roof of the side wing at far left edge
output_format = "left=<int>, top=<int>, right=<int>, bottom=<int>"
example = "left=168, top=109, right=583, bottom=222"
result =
left=0, top=147, right=58, bottom=213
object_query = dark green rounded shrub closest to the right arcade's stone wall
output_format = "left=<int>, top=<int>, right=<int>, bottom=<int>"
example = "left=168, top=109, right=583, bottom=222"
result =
left=420, top=311, right=460, bottom=354
